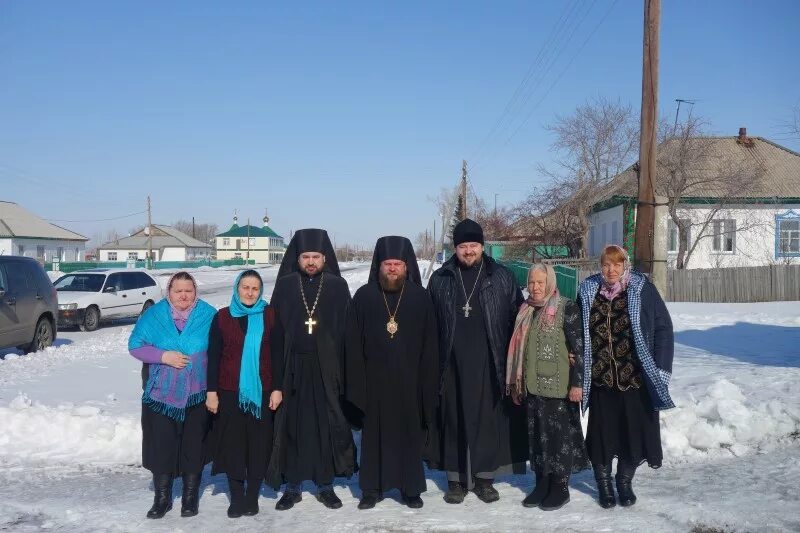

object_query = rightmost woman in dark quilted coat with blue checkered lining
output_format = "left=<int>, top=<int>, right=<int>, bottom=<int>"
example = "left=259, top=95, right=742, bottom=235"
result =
left=579, top=245, right=675, bottom=508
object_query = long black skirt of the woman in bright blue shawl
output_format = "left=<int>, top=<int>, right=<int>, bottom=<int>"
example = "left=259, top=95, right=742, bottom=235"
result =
left=142, top=403, right=209, bottom=476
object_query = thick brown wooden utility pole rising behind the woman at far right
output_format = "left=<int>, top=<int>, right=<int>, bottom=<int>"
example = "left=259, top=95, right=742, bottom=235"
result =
left=634, top=0, right=666, bottom=294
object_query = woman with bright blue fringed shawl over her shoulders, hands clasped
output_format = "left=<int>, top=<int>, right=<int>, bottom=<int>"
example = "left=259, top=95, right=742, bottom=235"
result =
left=128, top=272, right=216, bottom=518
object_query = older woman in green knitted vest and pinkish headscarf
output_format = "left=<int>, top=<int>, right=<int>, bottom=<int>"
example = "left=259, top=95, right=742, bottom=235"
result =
left=506, top=264, right=589, bottom=511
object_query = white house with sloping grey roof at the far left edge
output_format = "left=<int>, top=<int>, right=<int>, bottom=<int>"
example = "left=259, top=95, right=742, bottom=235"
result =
left=0, top=200, right=89, bottom=263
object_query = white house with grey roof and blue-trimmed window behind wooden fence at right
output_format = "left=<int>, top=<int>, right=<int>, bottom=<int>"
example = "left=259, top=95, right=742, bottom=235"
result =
left=589, top=129, right=800, bottom=268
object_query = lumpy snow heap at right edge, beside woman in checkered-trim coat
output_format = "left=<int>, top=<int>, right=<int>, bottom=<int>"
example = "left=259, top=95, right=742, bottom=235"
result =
left=661, top=378, right=800, bottom=461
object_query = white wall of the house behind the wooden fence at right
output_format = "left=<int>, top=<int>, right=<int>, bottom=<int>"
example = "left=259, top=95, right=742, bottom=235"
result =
left=667, top=204, right=800, bottom=268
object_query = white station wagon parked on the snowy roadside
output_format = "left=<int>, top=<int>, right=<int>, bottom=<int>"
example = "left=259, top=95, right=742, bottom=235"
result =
left=53, top=268, right=161, bottom=331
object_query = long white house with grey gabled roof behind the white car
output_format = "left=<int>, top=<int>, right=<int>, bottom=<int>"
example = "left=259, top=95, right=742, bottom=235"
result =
left=97, top=224, right=212, bottom=261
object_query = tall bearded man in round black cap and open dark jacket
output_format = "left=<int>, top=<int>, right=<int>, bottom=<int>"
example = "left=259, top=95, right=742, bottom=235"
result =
left=427, top=219, right=528, bottom=503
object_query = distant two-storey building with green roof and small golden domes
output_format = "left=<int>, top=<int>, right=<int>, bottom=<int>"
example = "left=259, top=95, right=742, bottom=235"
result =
left=216, top=211, right=286, bottom=264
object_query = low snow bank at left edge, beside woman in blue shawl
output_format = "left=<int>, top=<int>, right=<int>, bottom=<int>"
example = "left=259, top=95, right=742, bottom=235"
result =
left=0, top=394, right=142, bottom=465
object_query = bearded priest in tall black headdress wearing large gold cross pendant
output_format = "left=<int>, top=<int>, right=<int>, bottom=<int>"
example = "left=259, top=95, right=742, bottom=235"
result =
left=266, top=229, right=356, bottom=511
